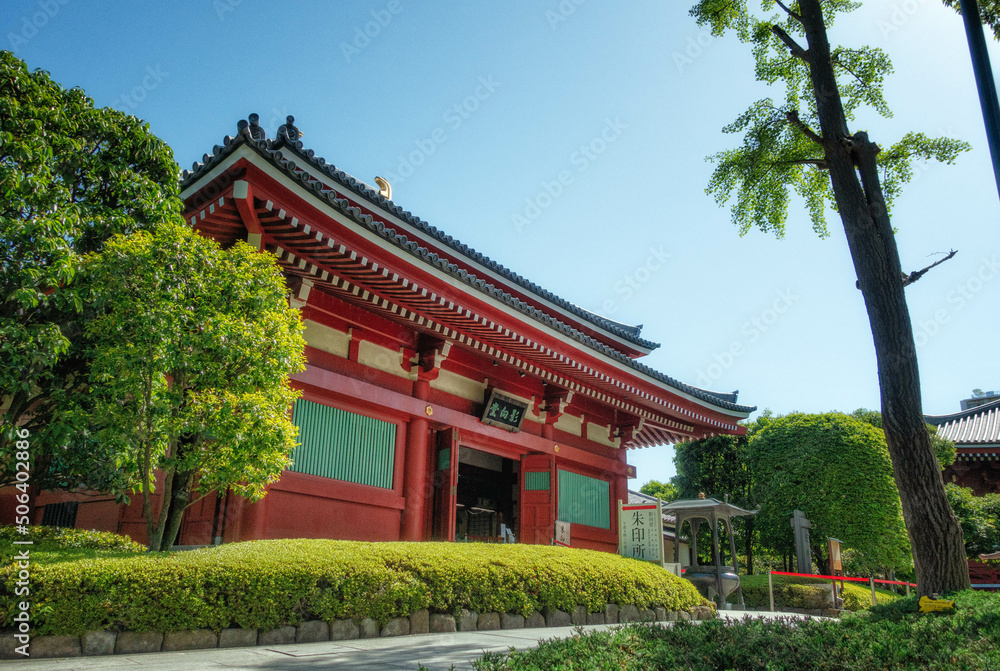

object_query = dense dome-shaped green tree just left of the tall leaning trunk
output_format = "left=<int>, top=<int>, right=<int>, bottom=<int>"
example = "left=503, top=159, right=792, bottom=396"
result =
left=750, top=413, right=909, bottom=573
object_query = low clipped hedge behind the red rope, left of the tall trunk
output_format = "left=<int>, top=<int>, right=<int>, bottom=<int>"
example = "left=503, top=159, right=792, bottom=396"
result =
left=728, top=574, right=901, bottom=612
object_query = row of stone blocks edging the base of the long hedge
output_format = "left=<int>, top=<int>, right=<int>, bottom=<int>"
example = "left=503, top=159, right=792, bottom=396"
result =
left=0, top=603, right=715, bottom=659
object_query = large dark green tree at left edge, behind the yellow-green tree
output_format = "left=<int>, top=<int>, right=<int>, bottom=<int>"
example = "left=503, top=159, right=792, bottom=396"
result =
left=0, top=51, right=181, bottom=490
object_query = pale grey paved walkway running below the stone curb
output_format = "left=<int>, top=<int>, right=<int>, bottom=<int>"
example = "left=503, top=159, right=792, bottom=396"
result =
left=0, top=611, right=805, bottom=671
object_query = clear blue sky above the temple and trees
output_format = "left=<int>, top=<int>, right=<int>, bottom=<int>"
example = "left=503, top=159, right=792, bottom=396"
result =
left=0, top=0, right=1000, bottom=485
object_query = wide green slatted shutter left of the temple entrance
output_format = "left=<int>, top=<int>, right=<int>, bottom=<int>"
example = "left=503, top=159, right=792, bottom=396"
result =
left=288, top=400, right=396, bottom=489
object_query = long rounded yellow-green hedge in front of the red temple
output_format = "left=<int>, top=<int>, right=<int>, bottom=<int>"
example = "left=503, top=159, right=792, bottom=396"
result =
left=0, top=539, right=707, bottom=635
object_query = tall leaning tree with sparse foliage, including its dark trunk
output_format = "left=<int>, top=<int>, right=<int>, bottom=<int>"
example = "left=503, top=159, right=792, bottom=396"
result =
left=691, top=0, right=969, bottom=594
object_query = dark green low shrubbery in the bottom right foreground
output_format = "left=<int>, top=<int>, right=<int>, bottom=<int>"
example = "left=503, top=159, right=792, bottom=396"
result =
left=475, top=590, right=1000, bottom=671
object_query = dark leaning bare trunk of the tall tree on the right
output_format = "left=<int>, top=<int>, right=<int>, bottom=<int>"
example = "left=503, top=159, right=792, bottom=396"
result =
left=793, top=0, right=969, bottom=595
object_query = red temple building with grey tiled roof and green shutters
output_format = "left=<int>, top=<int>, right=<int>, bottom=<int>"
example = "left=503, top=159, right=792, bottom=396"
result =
left=27, top=115, right=755, bottom=552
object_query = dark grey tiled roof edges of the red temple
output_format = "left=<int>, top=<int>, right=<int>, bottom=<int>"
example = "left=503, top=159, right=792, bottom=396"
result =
left=181, top=121, right=757, bottom=413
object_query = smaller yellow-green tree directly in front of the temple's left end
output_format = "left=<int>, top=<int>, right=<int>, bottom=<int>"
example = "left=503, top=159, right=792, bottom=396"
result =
left=84, top=223, right=305, bottom=550
